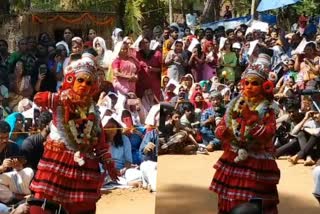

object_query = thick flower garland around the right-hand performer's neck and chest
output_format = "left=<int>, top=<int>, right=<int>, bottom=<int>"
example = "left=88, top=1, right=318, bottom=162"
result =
left=226, top=96, right=270, bottom=148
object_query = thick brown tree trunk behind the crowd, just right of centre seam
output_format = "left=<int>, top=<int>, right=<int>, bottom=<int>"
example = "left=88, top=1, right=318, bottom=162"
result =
left=201, top=0, right=221, bottom=23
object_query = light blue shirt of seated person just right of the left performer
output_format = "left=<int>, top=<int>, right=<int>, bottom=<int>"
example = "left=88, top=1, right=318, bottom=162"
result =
left=111, top=135, right=132, bottom=170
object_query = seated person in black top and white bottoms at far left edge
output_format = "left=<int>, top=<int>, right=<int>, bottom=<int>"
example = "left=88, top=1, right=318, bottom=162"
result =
left=0, top=121, right=33, bottom=204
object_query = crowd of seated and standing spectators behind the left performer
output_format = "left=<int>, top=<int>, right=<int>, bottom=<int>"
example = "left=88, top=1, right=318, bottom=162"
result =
left=0, top=26, right=162, bottom=213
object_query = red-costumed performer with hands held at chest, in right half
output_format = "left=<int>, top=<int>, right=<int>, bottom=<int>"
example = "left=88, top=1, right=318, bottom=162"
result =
left=209, top=53, right=280, bottom=214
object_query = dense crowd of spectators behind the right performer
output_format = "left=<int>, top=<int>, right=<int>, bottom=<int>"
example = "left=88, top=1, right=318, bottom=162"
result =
left=159, top=18, right=320, bottom=210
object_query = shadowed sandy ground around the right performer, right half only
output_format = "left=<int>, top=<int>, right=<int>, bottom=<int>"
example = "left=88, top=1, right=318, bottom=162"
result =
left=155, top=152, right=320, bottom=214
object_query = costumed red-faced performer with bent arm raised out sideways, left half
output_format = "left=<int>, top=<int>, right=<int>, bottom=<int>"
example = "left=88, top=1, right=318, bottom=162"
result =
left=30, top=53, right=117, bottom=213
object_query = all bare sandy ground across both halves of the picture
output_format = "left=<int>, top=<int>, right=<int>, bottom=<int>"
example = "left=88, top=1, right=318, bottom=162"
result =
left=97, top=152, right=320, bottom=214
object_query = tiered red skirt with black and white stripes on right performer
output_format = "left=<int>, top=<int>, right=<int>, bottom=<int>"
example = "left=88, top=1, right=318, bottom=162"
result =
left=209, top=151, right=280, bottom=213
